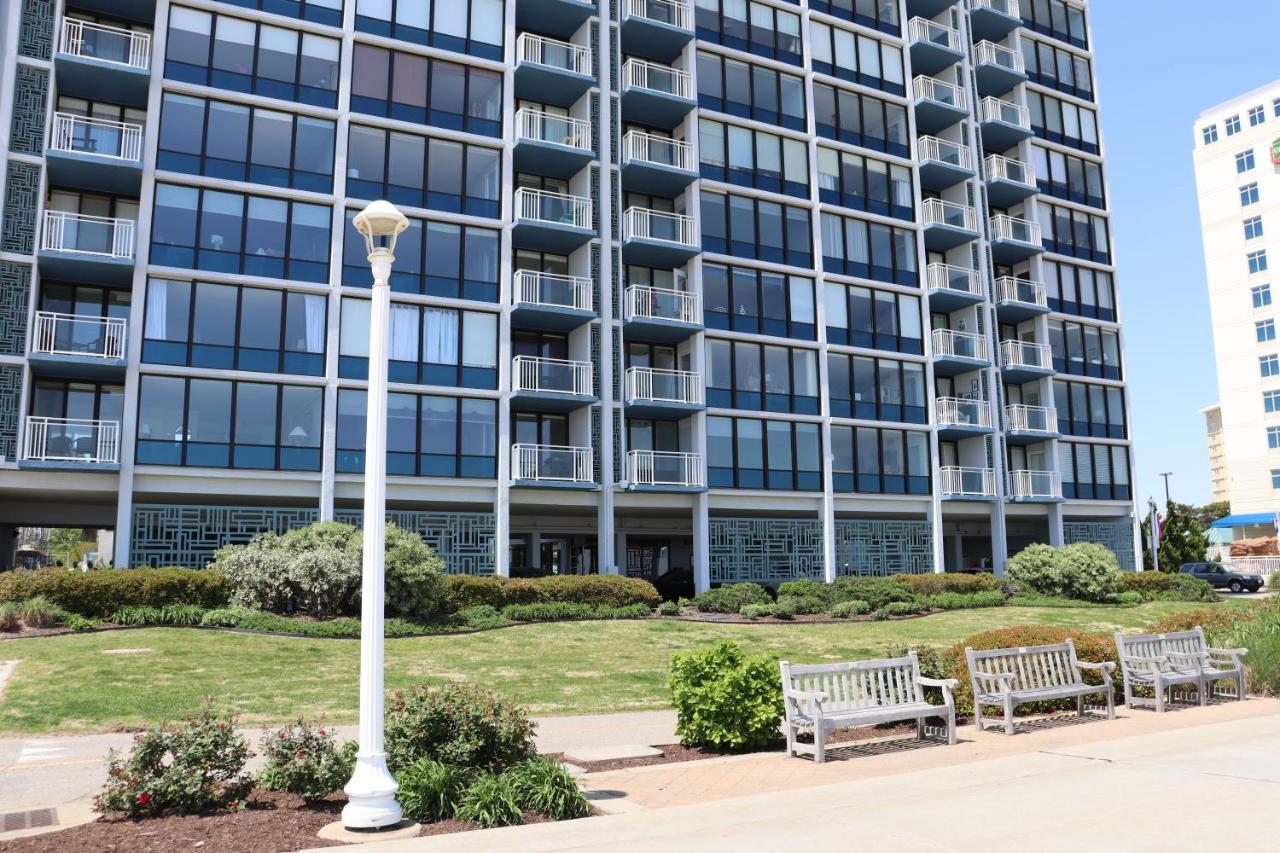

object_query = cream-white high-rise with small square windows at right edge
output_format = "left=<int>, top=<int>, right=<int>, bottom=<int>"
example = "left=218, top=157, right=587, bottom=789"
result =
left=1193, top=81, right=1280, bottom=515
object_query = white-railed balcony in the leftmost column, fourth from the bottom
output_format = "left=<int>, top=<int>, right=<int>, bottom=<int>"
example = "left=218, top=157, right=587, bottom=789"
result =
left=45, top=113, right=142, bottom=196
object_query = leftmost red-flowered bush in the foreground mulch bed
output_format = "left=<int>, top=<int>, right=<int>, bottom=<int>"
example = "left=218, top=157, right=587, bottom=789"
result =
left=95, top=706, right=253, bottom=816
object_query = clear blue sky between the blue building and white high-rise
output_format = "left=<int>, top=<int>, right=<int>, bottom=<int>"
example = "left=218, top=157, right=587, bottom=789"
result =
left=1085, top=0, right=1280, bottom=506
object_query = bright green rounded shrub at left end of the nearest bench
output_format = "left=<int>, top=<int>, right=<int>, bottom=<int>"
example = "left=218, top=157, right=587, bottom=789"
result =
left=668, top=640, right=782, bottom=749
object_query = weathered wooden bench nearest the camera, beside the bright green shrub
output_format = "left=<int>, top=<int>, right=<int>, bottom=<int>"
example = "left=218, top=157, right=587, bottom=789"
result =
left=781, top=652, right=959, bottom=763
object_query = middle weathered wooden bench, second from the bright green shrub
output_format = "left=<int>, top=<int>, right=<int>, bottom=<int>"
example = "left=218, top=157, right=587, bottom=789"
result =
left=964, top=638, right=1116, bottom=734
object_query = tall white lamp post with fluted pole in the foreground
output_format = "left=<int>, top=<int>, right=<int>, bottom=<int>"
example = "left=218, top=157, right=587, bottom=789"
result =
left=342, top=201, right=408, bottom=830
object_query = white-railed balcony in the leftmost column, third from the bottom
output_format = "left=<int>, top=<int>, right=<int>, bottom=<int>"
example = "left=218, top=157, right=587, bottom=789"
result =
left=38, top=210, right=133, bottom=284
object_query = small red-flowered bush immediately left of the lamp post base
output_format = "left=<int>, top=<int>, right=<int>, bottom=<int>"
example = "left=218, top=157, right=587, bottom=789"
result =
left=259, top=720, right=356, bottom=800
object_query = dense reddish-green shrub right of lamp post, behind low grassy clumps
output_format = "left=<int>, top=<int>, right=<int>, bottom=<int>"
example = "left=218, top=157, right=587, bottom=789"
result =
left=387, top=684, right=536, bottom=771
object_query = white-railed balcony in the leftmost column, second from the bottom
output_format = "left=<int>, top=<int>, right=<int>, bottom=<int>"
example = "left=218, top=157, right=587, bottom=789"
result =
left=27, top=311, right=128, bottom=379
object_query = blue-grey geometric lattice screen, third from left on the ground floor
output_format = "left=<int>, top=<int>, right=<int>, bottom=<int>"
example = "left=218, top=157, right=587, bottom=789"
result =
left=707, top=519, right=823, bottom=584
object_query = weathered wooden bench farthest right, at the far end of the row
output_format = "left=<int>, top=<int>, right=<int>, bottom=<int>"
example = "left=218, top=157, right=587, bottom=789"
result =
left=1116, top=625, right=1249, bottom=712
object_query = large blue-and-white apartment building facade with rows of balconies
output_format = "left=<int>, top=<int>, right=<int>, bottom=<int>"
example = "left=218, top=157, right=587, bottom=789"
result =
left=0, top=0, right=1135, bottom=588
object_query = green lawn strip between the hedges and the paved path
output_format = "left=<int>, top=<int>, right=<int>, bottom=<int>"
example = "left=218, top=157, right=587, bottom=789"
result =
left=0, top=602, right=1244, bottom=733
